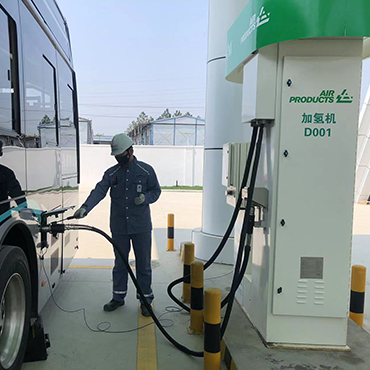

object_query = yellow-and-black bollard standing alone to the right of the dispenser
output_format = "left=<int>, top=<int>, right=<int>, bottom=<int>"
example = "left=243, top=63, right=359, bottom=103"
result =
left=349, top=265, right=366, bottom=328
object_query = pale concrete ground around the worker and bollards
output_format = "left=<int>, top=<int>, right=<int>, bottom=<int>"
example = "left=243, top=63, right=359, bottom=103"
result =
left=23, top=190, right=370, bottom=370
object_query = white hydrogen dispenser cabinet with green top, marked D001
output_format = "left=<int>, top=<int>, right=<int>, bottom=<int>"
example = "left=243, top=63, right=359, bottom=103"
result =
left=223, top=0, right=370, bottom=349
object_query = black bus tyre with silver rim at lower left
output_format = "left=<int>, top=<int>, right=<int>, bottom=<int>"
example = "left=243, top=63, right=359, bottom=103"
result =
left=0, top=246, right=31, bottom=370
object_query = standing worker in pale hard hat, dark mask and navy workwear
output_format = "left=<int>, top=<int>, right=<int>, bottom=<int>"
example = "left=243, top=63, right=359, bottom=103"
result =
left=74, top=134, right=161, bottom=316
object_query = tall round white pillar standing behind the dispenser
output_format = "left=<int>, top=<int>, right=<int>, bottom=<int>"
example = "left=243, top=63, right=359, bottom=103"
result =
left=193, top=0, right=248, bottom=264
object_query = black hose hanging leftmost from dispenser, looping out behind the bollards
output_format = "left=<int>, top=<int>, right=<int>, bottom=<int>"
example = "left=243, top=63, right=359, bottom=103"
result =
left=167, top=127, right=258, bottom=312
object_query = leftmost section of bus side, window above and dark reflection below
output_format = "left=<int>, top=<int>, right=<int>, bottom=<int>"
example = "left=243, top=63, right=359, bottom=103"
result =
left=0, top=3, right=26, bottom=220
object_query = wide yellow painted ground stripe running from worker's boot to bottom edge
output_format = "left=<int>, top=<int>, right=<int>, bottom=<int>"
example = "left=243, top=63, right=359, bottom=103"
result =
left=136, top=306, right=158, bottom=370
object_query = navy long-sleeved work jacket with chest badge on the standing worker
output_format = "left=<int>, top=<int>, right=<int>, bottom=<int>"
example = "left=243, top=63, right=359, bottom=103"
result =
left=83, top=157, right=161, bottom=235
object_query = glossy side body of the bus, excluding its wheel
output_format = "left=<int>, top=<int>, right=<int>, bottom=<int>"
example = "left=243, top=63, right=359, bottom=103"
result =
left=0, top=0, right=79, bottom=316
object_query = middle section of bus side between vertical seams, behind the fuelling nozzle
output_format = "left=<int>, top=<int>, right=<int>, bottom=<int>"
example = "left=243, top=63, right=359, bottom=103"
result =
left=20, top=3, right=63, bottom=307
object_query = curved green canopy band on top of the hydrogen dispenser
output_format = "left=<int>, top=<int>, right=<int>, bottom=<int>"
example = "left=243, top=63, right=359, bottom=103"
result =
left=226, top=0, right=370, bottom=80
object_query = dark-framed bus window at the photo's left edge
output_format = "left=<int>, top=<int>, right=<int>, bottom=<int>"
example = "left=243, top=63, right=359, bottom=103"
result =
left=0, top=7, right=20, bottom=133
